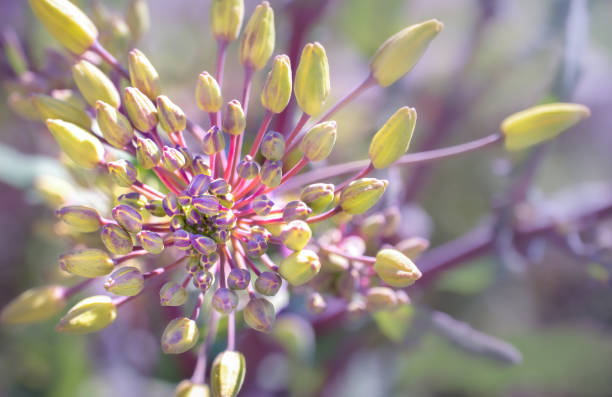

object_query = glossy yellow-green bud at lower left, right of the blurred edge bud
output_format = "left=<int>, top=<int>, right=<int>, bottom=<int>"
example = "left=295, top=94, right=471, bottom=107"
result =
left=55, top=295, right=117, bottom=334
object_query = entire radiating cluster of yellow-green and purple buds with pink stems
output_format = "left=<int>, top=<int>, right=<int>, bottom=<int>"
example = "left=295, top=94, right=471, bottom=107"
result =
left=2, top=0, right=588, bottom=396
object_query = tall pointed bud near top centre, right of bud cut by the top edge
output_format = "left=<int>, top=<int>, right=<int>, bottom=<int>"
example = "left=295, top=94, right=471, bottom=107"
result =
left=240, top=1, right=276, bottom=70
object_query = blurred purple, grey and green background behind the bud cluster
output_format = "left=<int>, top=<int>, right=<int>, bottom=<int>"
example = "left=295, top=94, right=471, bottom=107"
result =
left=0, top=0, right=612, bottom=397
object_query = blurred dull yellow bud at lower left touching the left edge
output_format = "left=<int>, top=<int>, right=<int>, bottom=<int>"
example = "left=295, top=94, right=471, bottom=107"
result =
left=0, top=285, right=66, bottom=324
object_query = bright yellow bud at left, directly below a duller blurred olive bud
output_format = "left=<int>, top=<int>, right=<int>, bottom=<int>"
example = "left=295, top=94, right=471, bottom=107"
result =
left=46, top=119, right=104, bottom=168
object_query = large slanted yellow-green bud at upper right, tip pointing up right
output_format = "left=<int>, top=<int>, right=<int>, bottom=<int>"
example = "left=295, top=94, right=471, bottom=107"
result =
left=370, top=19, right=444, bottom=87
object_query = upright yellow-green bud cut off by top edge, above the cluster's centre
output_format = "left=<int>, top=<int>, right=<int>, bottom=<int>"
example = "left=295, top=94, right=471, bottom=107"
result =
left=210, top=0, right=244, bottom=42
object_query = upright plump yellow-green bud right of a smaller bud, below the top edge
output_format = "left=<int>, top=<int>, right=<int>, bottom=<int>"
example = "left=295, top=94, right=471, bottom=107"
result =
left=294, top=43, right=330, bottom=116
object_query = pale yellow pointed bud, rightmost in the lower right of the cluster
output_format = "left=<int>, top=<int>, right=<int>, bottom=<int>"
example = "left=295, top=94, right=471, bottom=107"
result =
left=374, top=249, right=421, bottom=288
